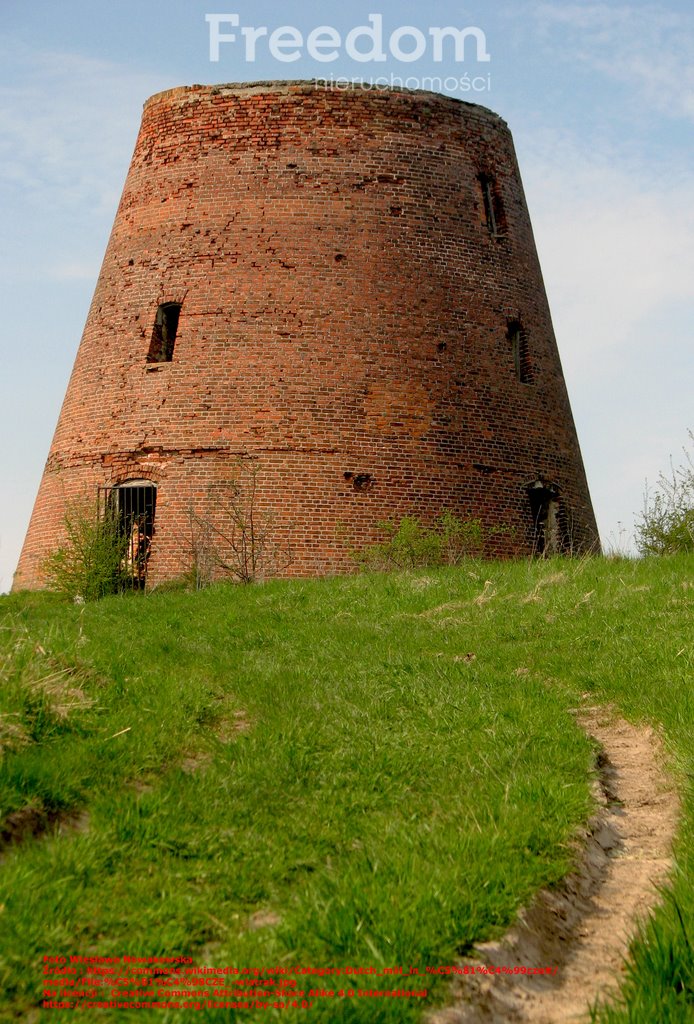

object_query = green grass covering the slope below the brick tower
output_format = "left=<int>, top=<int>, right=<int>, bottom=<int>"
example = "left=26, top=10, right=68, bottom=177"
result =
left=0, top=556, right=694, bottom=1024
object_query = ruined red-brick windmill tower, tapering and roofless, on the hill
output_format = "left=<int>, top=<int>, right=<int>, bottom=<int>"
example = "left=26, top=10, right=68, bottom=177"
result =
left=15, top=82, right=597, bottom=587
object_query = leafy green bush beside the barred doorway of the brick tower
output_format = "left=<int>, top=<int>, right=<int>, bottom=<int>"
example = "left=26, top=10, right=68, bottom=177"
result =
left=41, top=496, right=127, bottom=601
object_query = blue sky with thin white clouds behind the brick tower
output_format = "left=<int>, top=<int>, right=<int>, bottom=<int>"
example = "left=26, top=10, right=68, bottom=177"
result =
left=0, top=0, right=694, bottom=591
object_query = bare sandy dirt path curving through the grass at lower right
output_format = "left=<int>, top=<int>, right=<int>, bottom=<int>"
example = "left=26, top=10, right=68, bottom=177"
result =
left=426, top=708, right=679, bottom=1024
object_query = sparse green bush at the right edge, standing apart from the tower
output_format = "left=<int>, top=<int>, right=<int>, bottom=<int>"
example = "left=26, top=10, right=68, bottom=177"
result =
left=636, top=430, right=694, bottom=555
